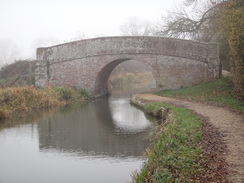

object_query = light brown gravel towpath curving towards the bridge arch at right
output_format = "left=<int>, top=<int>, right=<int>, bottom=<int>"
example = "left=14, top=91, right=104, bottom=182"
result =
left=134, top=94, right=244, bottom=183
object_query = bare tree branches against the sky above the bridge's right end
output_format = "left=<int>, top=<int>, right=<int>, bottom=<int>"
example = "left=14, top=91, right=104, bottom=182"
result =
left=156, top=0, right=223, bottom=41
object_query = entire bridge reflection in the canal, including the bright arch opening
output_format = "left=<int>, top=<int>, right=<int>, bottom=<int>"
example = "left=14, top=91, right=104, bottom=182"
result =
left=37, top=98, right=151, bottom=157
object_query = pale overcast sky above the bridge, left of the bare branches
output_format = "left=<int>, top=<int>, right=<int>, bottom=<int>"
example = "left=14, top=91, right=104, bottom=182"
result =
left=0, top=0, right=182, bottom=60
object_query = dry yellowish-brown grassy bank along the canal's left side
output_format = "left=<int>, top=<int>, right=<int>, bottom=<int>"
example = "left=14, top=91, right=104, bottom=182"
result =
left=0, top=86, right=89, bottom=119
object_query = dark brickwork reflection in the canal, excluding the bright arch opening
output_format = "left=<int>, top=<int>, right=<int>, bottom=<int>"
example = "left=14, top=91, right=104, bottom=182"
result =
left=38, top=98, right=150, bottom=157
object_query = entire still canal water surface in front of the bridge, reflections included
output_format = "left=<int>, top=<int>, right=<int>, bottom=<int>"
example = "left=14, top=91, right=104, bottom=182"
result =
left=0, top=83, right=155, bottom=183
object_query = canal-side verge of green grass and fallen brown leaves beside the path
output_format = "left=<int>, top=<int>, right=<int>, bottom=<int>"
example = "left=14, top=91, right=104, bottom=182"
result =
left=132, top=94, right=233, bottom=182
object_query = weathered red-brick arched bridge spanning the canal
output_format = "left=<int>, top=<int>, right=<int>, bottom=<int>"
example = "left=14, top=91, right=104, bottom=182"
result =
left=35, top=37, right=219, bottom=96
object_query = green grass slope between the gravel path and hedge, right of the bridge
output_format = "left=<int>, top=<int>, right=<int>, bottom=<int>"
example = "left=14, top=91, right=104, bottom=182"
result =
left=157, top=78, right=244, bottom=111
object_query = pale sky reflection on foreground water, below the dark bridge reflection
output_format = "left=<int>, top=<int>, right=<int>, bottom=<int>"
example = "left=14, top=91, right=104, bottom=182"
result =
left=0, top=124, right=145, bottom=183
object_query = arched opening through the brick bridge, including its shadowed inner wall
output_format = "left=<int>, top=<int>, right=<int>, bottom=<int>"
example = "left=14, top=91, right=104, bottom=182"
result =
left=94, top=58, right=156, bottom=97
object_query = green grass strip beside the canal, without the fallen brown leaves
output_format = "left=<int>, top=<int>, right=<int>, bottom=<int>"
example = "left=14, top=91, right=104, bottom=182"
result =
left=133, top=102, right=203, bottom=183
